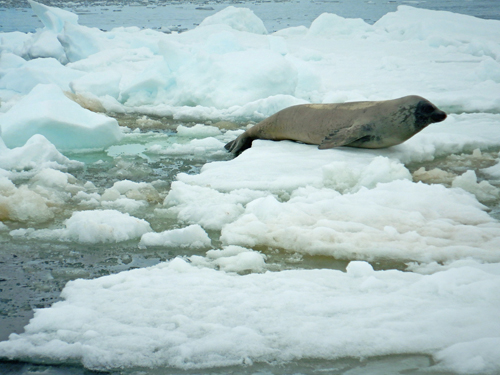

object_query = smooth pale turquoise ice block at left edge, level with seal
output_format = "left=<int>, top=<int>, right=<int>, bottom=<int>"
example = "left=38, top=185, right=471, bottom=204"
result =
left=0, top=84, right=122, bottom=150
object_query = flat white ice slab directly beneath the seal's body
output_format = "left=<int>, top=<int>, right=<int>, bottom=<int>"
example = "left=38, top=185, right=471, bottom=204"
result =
left=177, top=140, right=411, bottom=192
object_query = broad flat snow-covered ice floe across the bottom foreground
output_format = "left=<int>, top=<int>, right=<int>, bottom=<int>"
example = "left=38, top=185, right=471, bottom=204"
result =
left=0, top=258, right=500, bottom=373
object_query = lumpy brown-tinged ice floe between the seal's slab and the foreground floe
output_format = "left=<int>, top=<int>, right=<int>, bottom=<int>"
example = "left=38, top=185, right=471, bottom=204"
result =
left=221, top=180, right=500, bottom=262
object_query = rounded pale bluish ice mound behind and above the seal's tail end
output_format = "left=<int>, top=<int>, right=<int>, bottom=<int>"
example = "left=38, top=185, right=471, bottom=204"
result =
left=171, top=49, right=297, bottom=109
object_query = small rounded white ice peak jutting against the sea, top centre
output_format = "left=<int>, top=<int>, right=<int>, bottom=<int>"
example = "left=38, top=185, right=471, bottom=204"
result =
left=198, top=6, right=267, bottom=34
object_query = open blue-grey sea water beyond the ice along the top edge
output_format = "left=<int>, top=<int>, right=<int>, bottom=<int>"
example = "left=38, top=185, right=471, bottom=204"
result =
left=0, top=0, right=500, bottom=32
